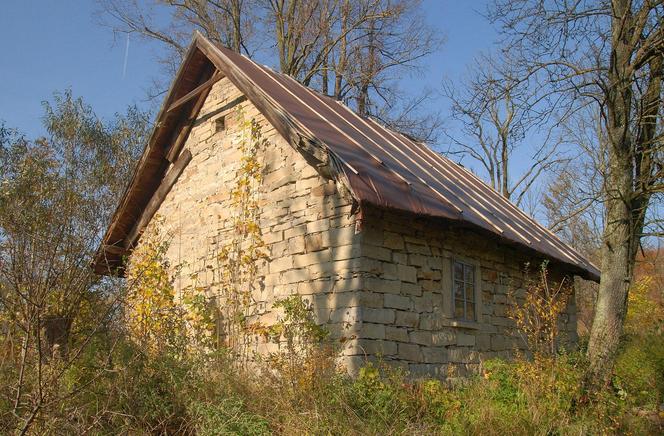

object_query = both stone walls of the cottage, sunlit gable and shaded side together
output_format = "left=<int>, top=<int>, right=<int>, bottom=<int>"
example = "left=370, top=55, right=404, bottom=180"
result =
left=134, top=79, right=576, bottom=376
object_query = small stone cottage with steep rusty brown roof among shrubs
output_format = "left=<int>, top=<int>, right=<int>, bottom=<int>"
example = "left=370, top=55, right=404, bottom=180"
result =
left=94, top=34, right=599, bottom=375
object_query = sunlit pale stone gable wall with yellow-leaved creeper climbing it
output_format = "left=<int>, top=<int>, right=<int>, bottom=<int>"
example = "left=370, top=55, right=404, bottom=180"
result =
left=139, top=78, right=361, bottom=358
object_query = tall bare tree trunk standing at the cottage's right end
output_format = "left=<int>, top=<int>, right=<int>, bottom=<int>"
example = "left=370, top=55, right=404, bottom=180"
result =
left=586, top=0, right=642, bottom=390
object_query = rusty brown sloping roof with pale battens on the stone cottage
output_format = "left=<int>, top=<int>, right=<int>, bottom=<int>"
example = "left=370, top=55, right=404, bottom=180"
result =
left=94, top=34, right=600, bottom=280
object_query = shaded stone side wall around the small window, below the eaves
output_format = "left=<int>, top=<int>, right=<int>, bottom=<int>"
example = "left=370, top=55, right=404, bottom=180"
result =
left=346, top=208, right=577, bottom=376
